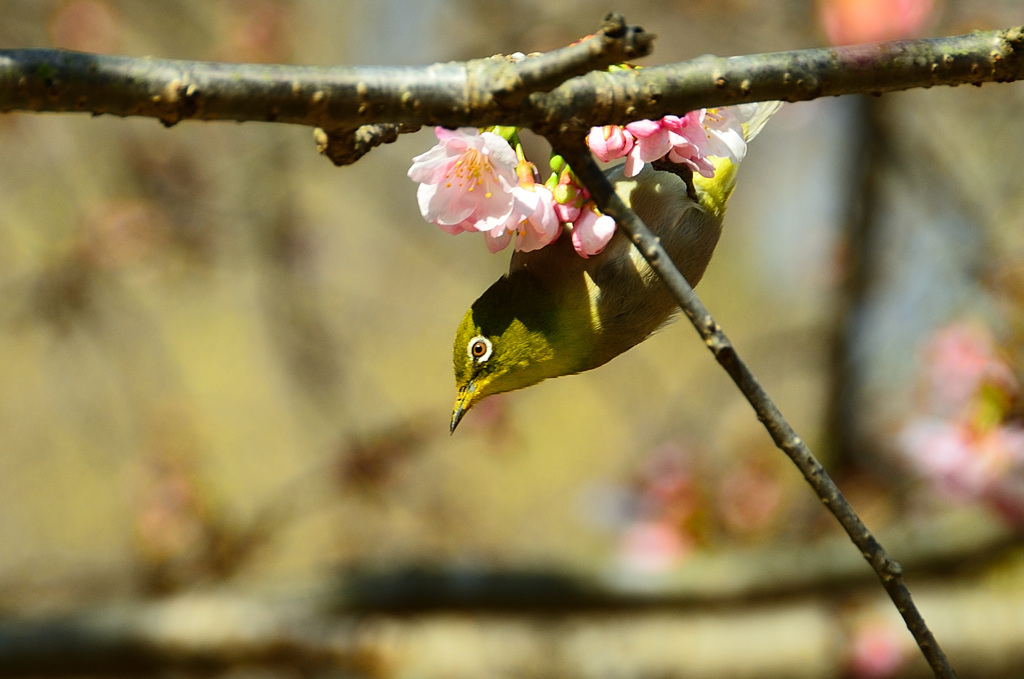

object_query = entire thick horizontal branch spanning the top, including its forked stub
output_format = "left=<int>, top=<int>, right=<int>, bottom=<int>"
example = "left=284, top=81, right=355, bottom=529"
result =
left=0, top=20, right=1024, bottom=163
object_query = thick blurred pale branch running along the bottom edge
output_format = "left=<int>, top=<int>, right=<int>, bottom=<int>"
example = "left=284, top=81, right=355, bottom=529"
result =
left=0, top=555, right=1024, bottom=679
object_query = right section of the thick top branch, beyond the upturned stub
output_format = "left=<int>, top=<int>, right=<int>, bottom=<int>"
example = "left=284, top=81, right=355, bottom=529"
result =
left=530, top=27, right=1024, bottom=132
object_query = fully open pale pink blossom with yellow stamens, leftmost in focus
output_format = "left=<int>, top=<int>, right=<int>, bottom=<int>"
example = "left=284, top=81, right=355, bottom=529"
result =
left=409, top=127, right=518, bottom=234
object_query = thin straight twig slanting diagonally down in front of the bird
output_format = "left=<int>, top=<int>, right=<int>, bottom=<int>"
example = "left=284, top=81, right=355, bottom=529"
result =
left=550, top=137, right=956, bottom=679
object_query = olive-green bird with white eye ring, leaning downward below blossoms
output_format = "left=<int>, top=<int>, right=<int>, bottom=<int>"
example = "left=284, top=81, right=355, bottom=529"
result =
left=451, top=102, right=779, bottom=432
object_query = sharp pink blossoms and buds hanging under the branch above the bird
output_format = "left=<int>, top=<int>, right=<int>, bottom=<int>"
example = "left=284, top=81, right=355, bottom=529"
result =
left=409, top=104, right=758, bottom=257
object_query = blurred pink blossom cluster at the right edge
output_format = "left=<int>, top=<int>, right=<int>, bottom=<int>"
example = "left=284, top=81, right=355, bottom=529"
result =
left=898, top=324, right=1024, bottom=525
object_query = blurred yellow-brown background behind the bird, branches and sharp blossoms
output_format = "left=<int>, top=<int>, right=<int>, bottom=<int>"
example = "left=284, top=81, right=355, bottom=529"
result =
left=0, top=0, right=1024, bottom=678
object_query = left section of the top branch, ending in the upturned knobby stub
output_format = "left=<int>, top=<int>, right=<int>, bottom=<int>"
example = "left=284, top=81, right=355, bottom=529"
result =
left=0, top=13, right=652, bottom=130
